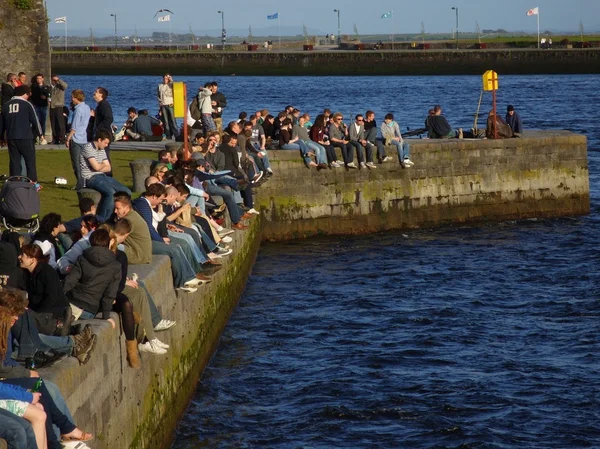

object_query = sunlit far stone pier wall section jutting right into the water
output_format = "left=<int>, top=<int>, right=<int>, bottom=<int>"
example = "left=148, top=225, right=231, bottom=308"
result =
left=257, top=131, right=590, bottom=240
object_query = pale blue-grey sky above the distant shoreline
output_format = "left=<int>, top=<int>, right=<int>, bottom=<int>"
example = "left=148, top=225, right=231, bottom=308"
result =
left=46, top=0, right=600, bottom=35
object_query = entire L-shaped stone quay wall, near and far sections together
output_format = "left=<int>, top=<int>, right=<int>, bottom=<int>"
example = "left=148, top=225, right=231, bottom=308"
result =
left=2, top=131, right=590, bottom=449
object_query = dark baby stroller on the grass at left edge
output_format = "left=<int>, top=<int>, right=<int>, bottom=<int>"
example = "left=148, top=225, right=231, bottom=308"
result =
left=0, top=176, right=40, bottom=233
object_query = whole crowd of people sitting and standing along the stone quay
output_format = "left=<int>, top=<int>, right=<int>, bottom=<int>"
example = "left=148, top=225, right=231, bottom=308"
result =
left=0, top=73, right=522, bottom=448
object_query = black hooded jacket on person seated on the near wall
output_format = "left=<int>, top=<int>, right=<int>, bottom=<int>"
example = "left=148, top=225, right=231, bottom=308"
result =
left=64, top=246, right=121, bottom=320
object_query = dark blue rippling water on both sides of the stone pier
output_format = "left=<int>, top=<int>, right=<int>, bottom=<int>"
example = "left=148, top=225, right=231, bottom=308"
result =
left=63, top=76, right=600, bottom=449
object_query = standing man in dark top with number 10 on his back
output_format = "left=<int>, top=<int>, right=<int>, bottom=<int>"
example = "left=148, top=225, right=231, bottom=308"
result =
left=0, top=85, right=42, bottom=182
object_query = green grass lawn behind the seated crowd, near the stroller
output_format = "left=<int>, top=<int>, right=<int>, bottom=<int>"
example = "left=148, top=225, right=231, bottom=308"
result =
left=0, top=149, right=156, bottom=221
